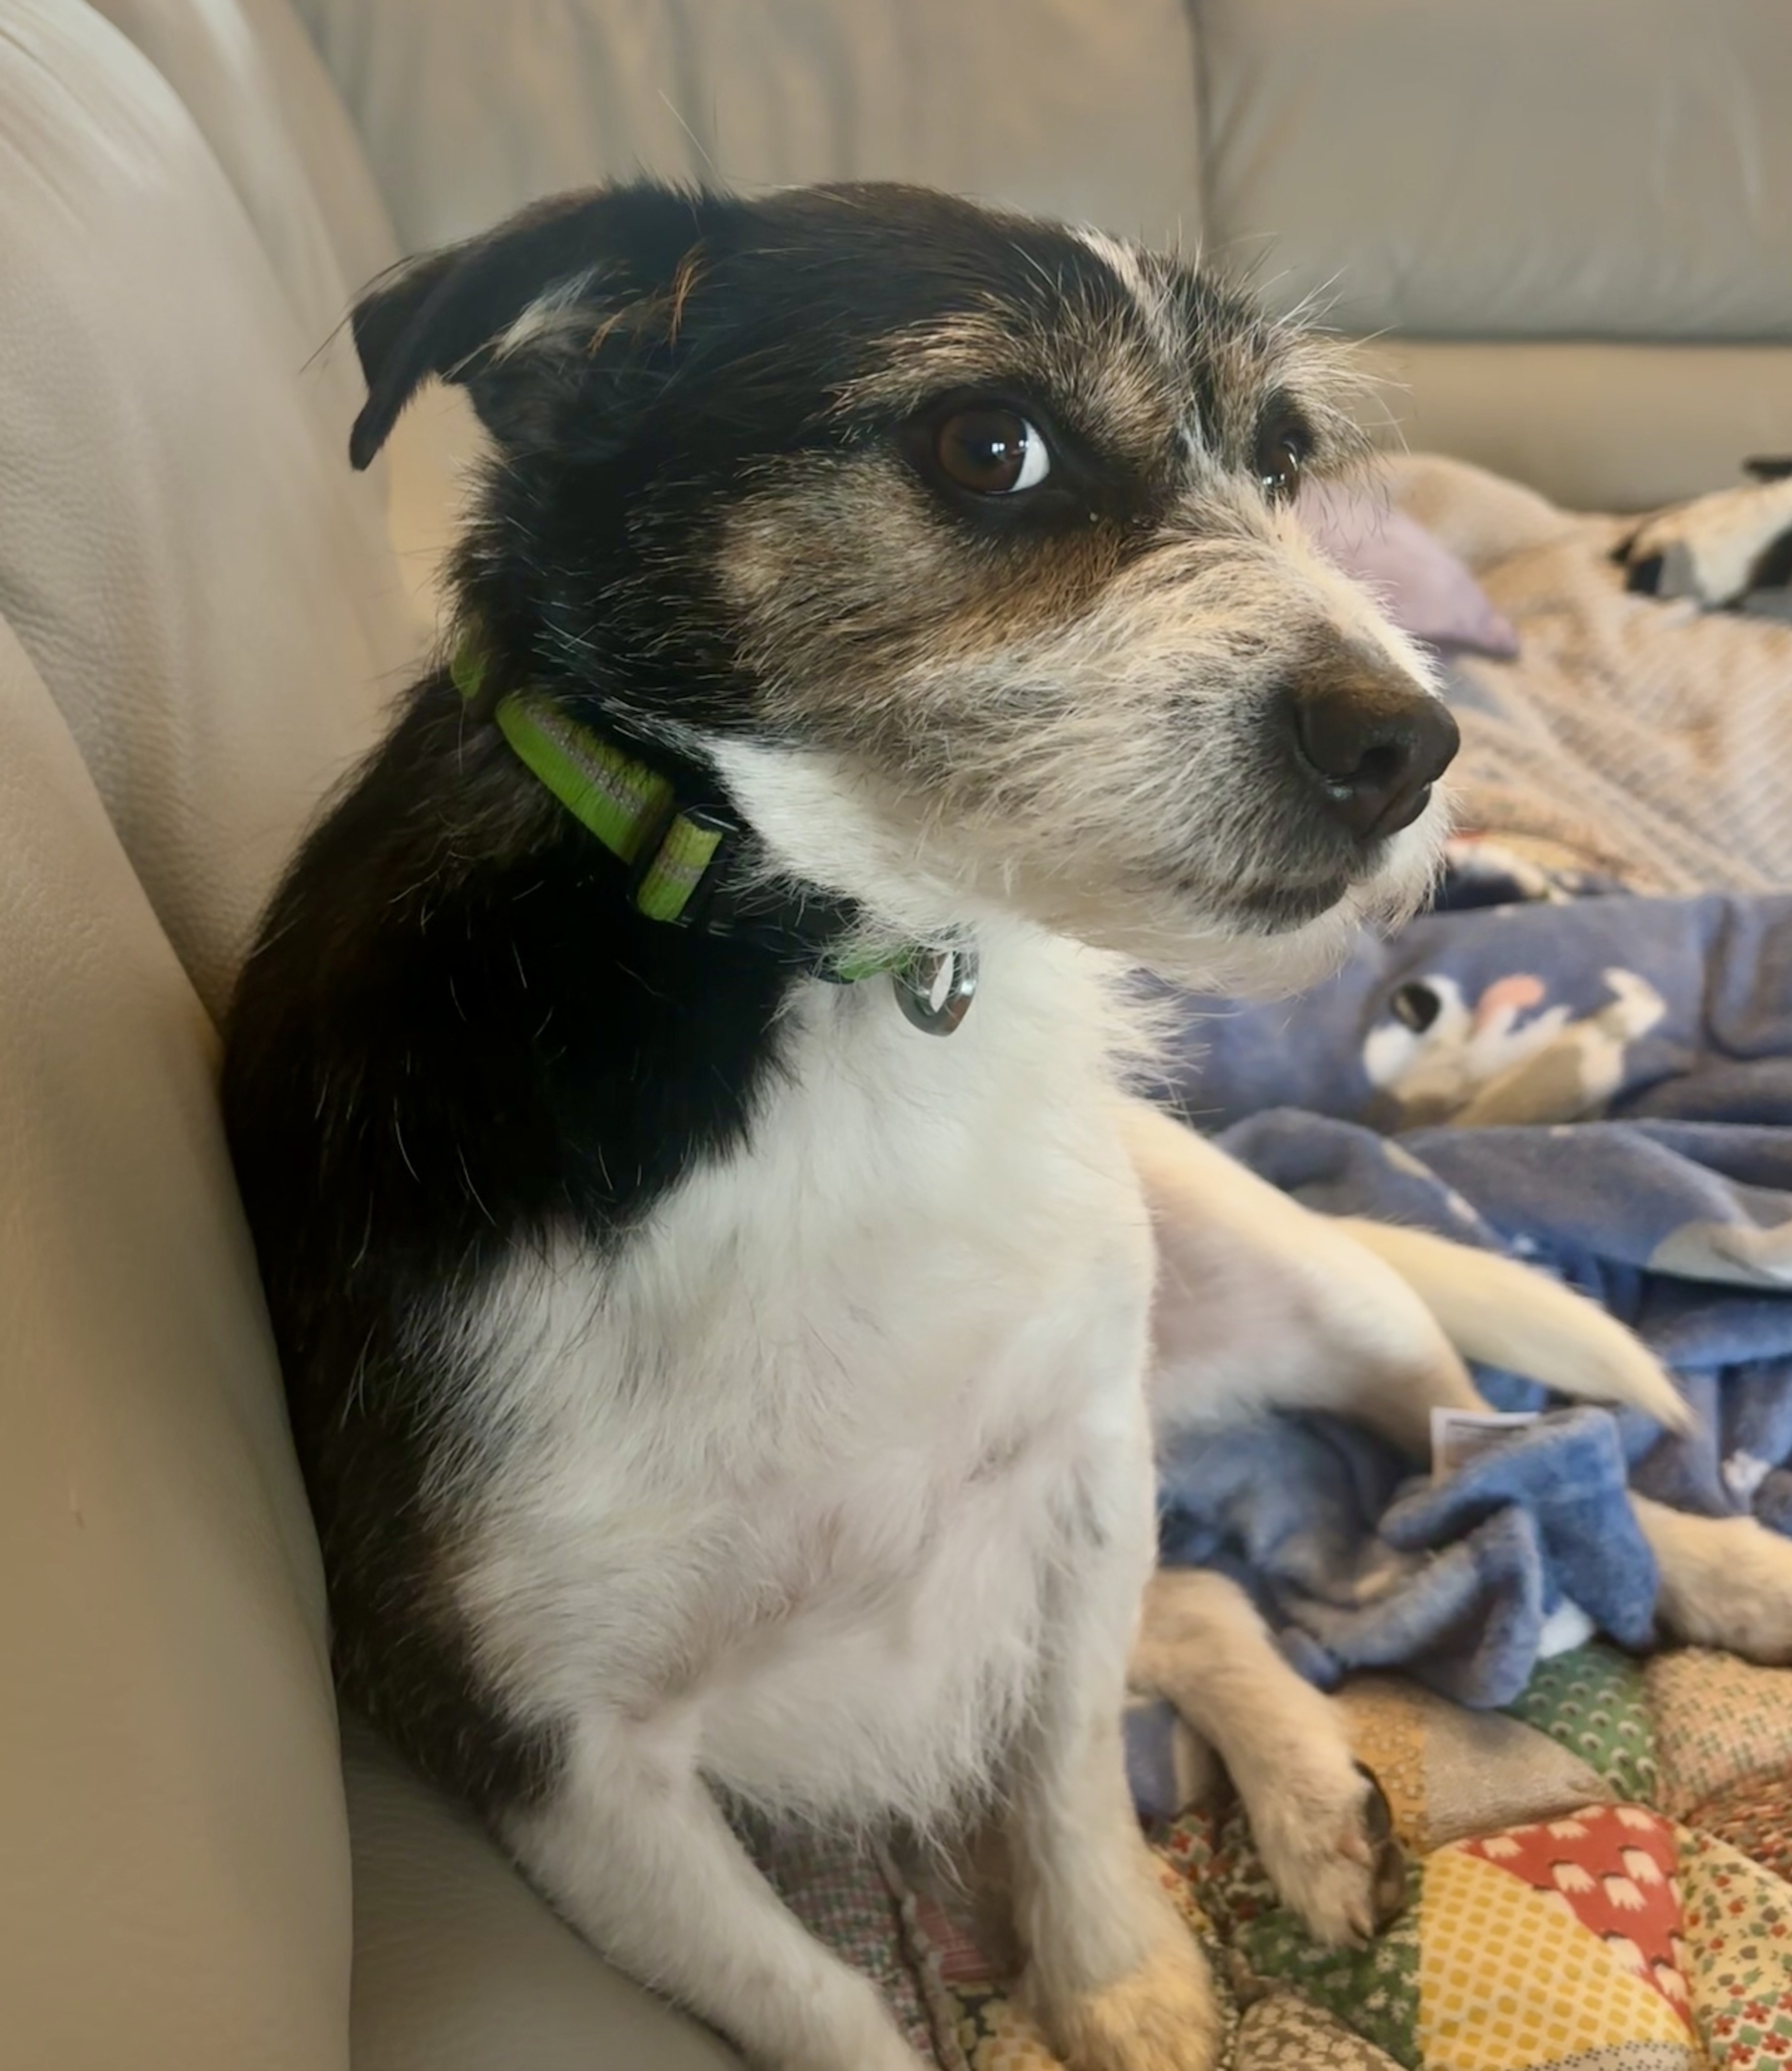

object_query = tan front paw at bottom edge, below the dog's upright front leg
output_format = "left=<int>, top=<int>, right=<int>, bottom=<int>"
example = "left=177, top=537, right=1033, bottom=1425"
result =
left=1021, top=1908, right=1223, bottom=2071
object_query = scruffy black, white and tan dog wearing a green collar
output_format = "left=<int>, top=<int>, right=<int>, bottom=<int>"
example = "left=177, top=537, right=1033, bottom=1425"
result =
left=224, top=184, right=1549, bottom=2071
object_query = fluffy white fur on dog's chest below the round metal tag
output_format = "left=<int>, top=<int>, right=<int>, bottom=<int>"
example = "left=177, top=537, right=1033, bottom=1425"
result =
left=441, top=936, right=1152, bottom=1820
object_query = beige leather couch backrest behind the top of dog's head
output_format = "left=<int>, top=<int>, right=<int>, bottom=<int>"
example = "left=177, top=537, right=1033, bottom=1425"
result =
left=301, top=0, right=1792, bottom=510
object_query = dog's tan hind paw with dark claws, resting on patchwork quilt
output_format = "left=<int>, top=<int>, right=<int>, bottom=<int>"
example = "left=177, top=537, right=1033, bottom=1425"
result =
left=1245, top=1760, right=1407, bottom=1949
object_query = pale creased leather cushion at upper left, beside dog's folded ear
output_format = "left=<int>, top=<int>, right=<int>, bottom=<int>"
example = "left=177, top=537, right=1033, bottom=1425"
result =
left=0, top=0, right=416, bottom=1011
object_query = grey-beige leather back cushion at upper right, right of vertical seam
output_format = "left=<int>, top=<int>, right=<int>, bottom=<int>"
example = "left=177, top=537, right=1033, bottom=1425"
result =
left=1196, top=0, right=1792, bottom=344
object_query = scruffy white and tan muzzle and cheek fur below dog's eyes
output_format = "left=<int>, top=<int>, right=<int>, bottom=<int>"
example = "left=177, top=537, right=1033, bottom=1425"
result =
left=704, top=382, right=1446, bottom=992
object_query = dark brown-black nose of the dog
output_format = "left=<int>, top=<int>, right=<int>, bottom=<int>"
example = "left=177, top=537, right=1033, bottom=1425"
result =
left=1295, top=673, right=1460, bottom=840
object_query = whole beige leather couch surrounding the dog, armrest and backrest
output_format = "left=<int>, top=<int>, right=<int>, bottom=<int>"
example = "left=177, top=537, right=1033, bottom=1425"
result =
left=0, top=0, right=1792, bottom=2071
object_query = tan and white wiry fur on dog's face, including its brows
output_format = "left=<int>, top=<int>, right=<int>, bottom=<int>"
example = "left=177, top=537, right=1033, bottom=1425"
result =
left=704, top=240, right=1436, bottom=982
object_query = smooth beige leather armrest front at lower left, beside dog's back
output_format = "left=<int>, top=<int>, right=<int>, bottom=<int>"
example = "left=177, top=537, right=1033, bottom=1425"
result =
left=0, top=623, right=350, bottom=2071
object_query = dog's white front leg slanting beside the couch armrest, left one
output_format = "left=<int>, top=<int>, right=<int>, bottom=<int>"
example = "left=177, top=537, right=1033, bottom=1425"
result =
left=506, top=1721, right=922, bottom=2071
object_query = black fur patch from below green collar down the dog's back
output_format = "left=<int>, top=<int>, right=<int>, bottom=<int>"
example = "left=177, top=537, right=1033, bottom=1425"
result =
left=224, top=677, right=791, bottom=1810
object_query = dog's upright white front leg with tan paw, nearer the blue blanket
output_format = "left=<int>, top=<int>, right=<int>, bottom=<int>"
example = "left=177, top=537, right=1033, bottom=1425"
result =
left=1008, top=1383, right=1221, bottom=2071
